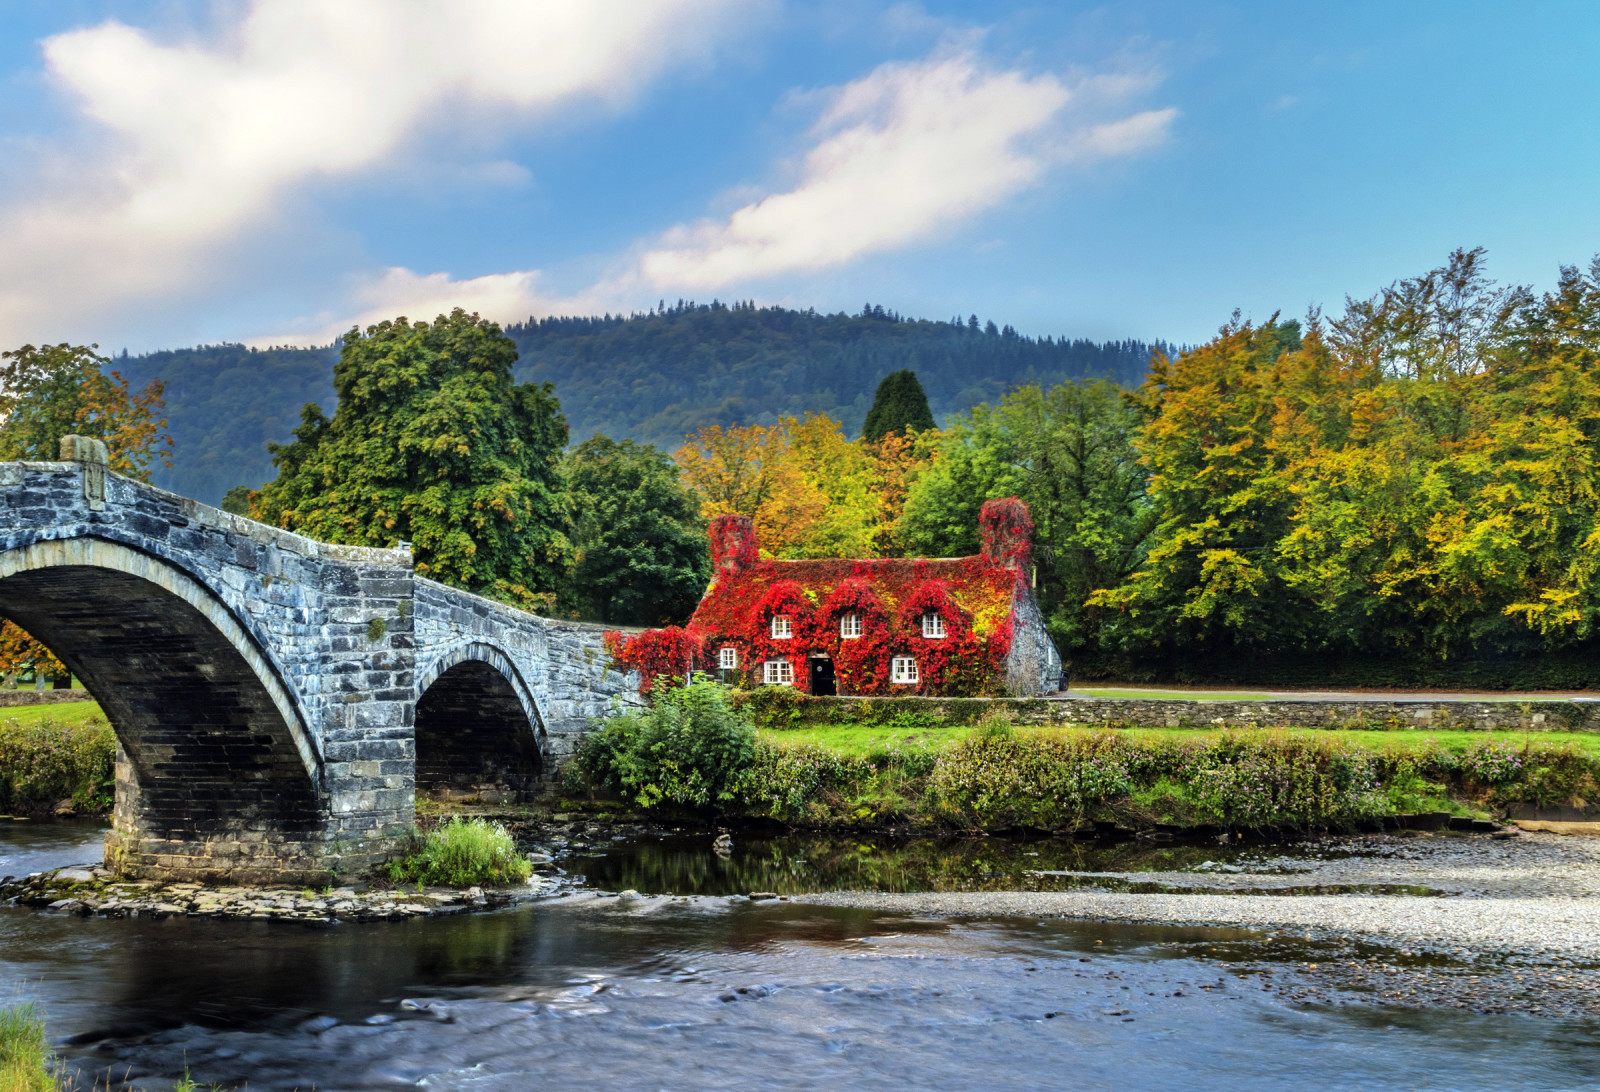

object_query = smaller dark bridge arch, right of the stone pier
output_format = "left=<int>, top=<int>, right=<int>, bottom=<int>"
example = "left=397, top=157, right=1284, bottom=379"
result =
left=414, top=640, right=549, bottom=797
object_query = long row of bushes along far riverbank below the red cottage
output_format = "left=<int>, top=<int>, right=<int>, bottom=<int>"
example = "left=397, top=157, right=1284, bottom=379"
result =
left=568, top=682, right=1600, bottom=833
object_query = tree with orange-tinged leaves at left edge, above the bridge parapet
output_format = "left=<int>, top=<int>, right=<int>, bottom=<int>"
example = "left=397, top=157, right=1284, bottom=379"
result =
left=0, top=343, right=173, bottom=482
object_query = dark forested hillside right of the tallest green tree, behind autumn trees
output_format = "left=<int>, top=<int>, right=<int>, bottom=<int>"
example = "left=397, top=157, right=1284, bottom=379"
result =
left=506, top=303, right=1150, bottom=450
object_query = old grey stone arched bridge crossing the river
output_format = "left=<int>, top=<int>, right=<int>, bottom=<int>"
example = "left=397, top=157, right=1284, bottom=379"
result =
left=0, top=437, right=637, bottom=884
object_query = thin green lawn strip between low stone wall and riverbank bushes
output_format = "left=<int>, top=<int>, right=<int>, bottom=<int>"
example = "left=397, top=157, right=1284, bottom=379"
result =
left=762, top=724, right=1600, bottom=754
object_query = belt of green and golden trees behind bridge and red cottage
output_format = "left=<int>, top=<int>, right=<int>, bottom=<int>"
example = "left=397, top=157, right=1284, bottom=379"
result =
left=9, top=250, right=1600, bottom=687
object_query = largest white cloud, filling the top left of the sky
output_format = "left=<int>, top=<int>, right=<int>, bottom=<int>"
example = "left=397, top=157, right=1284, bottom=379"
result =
left=0, top=0, right=750, bottom=344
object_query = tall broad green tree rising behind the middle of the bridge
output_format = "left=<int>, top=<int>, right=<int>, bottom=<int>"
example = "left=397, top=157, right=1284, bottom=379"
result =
left=256, top=307, right=571, bottom=605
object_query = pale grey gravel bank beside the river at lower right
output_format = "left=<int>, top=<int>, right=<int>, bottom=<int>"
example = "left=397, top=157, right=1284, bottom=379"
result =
left=794, top=834, right=1600, bottom=1018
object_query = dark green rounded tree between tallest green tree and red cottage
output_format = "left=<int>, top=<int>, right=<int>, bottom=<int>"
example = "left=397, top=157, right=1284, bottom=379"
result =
left=563, top=436, right=710, bottom=626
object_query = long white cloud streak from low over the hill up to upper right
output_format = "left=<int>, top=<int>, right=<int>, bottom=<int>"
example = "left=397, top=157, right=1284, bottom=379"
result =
left=256, top=48, right=1178, bottom=344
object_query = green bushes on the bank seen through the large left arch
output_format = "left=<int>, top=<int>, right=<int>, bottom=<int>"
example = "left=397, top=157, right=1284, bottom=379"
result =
left=0, top=717, right=117, bottom=812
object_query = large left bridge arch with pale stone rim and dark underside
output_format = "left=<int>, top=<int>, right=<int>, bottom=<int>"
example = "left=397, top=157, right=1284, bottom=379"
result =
left=0, top=536, right=323, bottom=882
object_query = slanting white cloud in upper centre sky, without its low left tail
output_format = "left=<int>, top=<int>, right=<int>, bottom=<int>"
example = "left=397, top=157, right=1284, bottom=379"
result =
left=635, top=50, right=1178, bottom=291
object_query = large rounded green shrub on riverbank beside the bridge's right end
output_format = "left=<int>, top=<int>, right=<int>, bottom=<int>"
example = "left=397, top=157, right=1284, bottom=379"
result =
left=576, top=679, right=758, bottom=807
